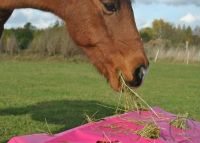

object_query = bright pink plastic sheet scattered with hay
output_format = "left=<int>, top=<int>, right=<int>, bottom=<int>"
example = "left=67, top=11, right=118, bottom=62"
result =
left=8, top=108, right=200, bottom=143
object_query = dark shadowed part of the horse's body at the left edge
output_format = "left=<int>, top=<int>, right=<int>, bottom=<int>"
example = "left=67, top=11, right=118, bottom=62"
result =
left=0, top=10, right=13, bottom=38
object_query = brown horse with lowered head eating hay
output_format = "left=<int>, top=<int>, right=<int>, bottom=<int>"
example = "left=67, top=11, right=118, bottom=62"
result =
left=0, top=0, right=149, bottom=91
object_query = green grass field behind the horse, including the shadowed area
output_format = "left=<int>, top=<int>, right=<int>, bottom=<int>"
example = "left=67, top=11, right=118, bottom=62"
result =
left=0, top=61, right=200, bottom=142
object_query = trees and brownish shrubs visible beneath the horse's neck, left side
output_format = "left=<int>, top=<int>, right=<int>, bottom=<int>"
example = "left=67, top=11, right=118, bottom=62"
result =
left=0, top=21, right=83, bottom=58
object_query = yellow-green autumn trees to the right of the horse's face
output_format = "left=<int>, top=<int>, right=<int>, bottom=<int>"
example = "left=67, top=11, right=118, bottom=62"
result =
left=140, top=19, right=200, bottom=48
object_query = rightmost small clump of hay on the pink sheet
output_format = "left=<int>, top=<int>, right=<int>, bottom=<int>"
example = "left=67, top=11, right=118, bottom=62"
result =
left=170, top=113, right=189, bottom=130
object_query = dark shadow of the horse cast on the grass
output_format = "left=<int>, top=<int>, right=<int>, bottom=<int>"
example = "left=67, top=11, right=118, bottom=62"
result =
left=0, top=100, right=114, bottom=130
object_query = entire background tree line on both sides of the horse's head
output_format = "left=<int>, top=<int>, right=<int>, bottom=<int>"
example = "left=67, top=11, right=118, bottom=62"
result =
left=0, top=19, right=200, bottom=58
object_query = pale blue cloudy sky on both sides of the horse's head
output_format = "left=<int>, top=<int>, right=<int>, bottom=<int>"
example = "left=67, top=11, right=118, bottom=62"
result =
left=5, top=0, right=200, bottom=29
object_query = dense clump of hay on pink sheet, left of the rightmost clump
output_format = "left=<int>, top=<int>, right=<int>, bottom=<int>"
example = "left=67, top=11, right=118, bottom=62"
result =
left=136, top=123, right=161, bottom=139
